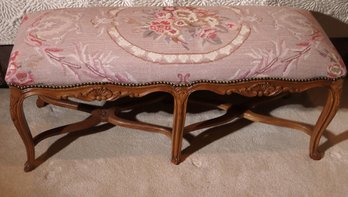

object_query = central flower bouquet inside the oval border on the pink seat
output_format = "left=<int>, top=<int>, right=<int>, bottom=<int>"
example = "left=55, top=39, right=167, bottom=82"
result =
left=136, top=7, right=240, bottom=50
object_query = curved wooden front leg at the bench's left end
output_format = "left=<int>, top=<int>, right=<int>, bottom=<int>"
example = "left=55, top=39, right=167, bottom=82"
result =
left=10, top=88, right=36, bottom=172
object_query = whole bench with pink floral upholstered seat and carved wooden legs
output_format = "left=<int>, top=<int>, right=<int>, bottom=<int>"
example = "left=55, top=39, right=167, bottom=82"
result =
left=6, top=6, right=346, bottom=171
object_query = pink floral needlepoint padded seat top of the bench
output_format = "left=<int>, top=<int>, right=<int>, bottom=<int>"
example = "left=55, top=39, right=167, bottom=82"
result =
left=6, top=6, right=346, bottom=86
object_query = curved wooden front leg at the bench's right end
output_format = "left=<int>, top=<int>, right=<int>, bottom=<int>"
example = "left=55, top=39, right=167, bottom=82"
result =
left=310, top=80, right=343, bottom=160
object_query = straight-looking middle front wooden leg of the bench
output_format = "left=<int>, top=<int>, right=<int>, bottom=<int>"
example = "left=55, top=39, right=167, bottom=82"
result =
left=172, top=90, right=189, bottom=165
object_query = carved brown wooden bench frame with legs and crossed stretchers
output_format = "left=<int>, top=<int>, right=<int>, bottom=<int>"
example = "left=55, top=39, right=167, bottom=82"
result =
left=10, top=78, right=343, bottom=172
